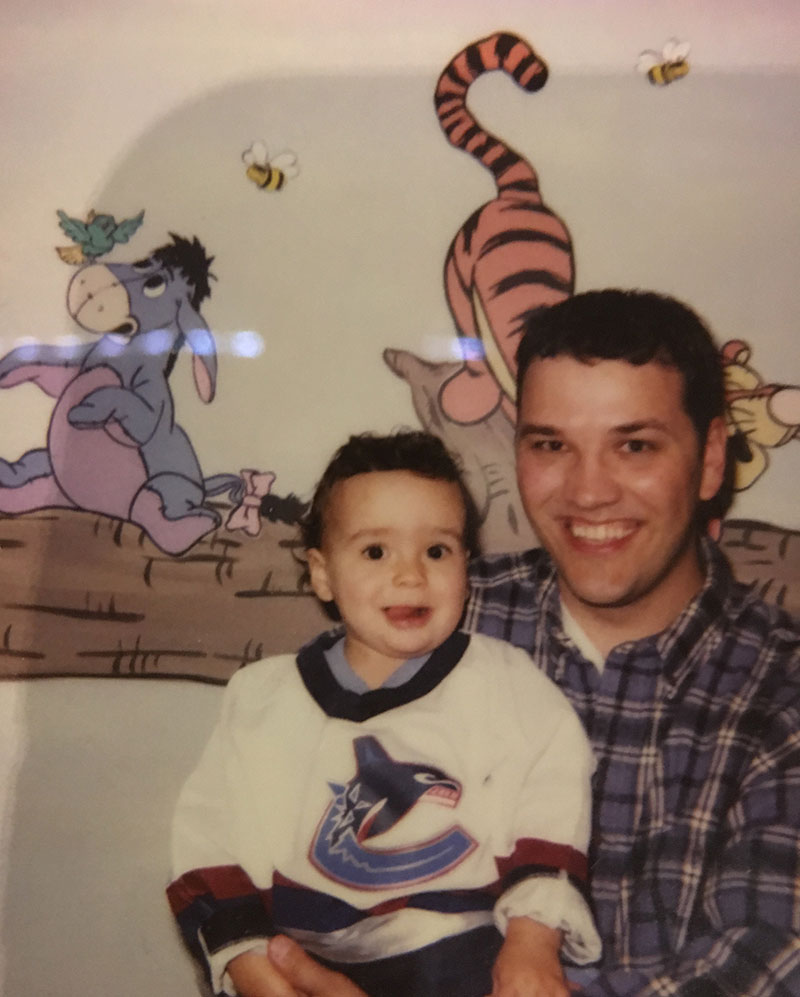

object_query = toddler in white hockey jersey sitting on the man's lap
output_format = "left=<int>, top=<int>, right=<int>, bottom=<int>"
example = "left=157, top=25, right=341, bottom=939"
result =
left=168, top=432, right=600, bottom=997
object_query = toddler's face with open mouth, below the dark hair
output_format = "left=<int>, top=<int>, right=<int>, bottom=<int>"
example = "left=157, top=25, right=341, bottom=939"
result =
left=309, top=471, right=467, bottom=684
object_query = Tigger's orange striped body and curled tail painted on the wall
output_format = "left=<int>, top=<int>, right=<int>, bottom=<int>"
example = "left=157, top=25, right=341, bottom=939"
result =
left=435, top=33, right=574, bottom=424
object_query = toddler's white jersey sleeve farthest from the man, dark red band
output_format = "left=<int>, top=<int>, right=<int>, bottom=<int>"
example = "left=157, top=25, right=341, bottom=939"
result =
left=167, top=676, right=273, bottom=994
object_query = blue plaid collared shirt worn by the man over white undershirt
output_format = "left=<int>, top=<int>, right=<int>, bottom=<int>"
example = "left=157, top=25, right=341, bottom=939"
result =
left=465, top=542, right=800, bottom=997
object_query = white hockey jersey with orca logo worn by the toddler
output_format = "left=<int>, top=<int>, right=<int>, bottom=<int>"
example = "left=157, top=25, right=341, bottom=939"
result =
left=168, top=632, right=600, bottom=997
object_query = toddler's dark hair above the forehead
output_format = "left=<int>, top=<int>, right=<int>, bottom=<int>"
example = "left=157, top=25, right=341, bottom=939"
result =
left=300, top=430, right=480, bottom=557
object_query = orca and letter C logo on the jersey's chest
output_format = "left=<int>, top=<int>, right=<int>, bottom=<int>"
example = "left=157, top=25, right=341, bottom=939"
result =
left=310, top=737, right=475, bottom=890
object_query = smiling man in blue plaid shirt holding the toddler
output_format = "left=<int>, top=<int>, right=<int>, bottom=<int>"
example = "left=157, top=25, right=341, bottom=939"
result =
left=264, top=291, right=800, bottom=997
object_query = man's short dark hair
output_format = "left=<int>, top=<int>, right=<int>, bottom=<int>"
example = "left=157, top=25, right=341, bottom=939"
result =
left=517, top=288, right=725, bottom=444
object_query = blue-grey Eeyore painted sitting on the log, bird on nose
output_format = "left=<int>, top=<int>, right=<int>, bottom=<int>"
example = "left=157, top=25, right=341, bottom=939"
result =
left=0, top=233, right=242, bottom=554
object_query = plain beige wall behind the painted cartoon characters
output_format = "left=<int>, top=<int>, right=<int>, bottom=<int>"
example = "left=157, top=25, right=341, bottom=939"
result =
left=0, top=0, right=800, bottom=997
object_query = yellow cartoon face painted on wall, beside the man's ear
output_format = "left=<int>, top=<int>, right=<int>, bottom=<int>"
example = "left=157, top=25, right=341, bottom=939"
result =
left=720, top=339, right=800, bottom=492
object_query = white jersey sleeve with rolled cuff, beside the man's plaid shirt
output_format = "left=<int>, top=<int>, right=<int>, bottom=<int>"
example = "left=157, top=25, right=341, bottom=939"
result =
left=495, top=649, right=602, bottom=965
